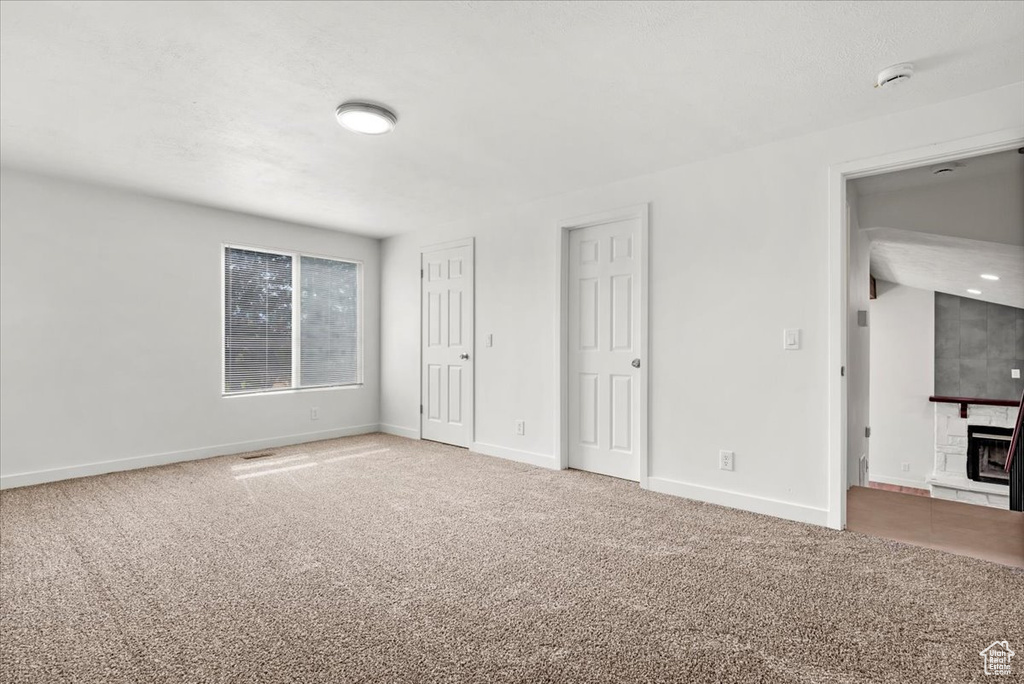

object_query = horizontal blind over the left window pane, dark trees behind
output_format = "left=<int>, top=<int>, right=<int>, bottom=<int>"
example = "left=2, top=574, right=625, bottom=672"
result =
left=224, top=248, right=292, bottom=394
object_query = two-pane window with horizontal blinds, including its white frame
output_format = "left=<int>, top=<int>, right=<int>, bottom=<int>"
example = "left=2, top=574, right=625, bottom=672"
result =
left=224, top=247, right=362, bottom=394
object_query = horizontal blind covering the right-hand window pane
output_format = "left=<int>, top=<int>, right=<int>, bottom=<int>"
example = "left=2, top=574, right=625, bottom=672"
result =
left=299, top=256, right=359, bottom=387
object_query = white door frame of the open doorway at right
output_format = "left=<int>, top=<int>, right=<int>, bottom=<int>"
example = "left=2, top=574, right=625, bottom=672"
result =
left=826, top=127, right=1024, bottom=529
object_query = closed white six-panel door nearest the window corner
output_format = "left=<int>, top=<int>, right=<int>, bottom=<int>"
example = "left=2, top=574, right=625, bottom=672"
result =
left=420, top=243, right=474, bottom=446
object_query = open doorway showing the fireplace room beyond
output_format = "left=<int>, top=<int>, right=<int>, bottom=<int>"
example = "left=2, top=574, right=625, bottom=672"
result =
left=841, top=140, right=1024, bottom=564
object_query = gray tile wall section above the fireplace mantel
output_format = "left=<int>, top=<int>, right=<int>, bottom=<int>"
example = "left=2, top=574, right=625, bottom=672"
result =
left=935, top=292, right=1024, bottom=399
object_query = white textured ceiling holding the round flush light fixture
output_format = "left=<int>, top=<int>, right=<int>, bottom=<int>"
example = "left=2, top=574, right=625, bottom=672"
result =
left=0, top=1, right=1024, bottom=236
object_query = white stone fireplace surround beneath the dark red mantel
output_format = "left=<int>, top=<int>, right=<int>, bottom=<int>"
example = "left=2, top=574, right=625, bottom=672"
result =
left=928, top=402, right=1018, bottom=509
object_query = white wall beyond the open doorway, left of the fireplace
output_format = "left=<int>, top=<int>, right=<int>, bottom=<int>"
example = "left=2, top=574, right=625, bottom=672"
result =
left=870, top=281, right=935, bottom=489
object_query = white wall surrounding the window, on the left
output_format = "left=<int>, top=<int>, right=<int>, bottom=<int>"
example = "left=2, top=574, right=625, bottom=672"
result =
left=0, top=170, right=380, bottom=485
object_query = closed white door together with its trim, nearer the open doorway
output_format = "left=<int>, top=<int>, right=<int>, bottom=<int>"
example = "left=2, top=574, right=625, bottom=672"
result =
left=557, top=205, right=649, bottom=487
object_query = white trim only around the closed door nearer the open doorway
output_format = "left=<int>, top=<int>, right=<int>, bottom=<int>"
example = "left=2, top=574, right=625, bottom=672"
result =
left=555, top=203, right=650, bottom=489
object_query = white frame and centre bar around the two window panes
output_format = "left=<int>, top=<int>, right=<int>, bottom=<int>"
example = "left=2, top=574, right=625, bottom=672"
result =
left=220, top=243, right=365, bottom=398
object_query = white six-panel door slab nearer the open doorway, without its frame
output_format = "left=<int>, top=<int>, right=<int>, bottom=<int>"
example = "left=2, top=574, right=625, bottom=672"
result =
left=567, top=218, right=645, bottom=480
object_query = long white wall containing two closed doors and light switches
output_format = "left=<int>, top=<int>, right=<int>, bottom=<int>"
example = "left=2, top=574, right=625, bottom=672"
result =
left=381, top=84, right=1024, bottom=524
